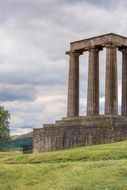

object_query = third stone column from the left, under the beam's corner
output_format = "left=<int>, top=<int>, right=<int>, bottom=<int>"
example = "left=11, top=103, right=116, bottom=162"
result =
left=105, top=45, right=118, bottom=115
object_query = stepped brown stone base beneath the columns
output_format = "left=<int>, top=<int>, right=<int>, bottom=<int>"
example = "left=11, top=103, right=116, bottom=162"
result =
left=33, top=115, right=127, bottom=152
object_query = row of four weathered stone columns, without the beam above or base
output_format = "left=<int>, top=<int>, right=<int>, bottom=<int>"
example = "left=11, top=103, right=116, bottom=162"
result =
left=67, top=40, right=127, bottom=117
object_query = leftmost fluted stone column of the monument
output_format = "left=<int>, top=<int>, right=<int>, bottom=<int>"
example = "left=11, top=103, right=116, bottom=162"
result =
left=67, top=52, right=80, bottom=117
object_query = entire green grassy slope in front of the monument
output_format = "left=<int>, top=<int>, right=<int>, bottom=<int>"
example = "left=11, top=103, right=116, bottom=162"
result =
left=0, top=141, right=127, bottom=190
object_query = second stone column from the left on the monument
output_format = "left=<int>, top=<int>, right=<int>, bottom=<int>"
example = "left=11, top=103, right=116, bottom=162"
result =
left=87, top=48, right=99, bottom=115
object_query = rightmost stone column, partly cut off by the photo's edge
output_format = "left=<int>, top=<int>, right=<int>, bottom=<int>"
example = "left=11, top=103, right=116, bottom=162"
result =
left=121, top=48, right=127, bottom=115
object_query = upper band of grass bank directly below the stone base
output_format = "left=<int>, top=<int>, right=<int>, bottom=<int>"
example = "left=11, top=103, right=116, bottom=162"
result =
left=0, top=141, right=127, bottom=164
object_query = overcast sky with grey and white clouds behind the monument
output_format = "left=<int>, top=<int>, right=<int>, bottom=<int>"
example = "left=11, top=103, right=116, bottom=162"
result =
left=0, top=0, right=127, bottom=134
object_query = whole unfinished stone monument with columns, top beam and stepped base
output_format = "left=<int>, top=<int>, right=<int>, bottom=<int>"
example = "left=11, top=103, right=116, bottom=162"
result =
left=33, top=33, right=127, bottom=152
